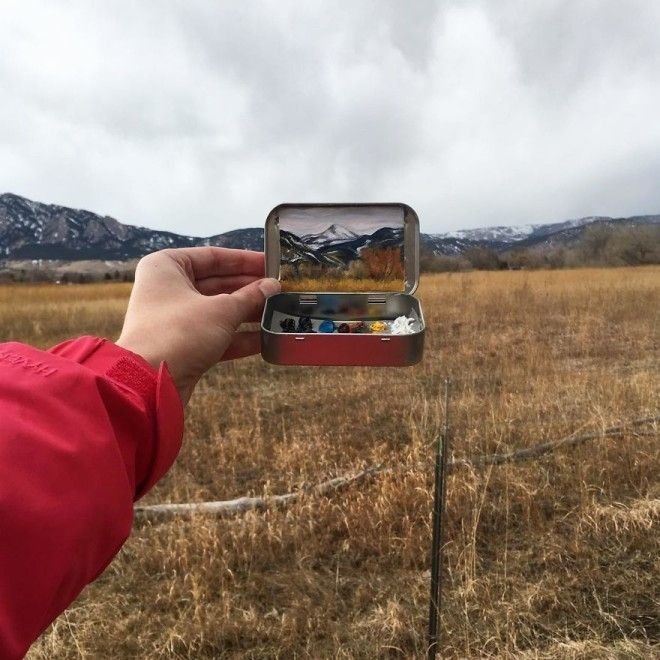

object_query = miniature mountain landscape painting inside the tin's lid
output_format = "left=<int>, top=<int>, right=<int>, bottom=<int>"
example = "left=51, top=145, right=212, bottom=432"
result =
left=279, top=207, right=405, bottom=291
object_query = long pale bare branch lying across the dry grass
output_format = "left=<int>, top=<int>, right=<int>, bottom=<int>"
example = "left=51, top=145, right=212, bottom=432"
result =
left=135, top=415, right=660, bottom=518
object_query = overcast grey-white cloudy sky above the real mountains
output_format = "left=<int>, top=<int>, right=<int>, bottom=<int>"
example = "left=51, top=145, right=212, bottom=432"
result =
left=0, top=0, right=660, bottom=235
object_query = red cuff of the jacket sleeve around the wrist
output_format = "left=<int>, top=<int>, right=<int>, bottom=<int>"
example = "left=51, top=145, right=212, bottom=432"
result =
left=49, top=337, right=183, bottom=499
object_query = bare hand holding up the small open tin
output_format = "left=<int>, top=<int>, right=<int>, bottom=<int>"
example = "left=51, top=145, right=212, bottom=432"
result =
left=116, top=247, right=280, bottom=405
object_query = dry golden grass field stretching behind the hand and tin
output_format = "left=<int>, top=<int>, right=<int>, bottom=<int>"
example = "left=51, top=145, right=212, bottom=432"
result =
left=0, top=267, right=660, bottom=660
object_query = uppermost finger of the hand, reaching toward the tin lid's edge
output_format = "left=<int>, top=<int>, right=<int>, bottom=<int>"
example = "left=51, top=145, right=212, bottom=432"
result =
left=170, top=246, right=264, bottom=280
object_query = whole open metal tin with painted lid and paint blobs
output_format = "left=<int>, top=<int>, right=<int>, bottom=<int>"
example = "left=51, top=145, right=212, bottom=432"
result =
left=261, top=204, right=425, bottom=367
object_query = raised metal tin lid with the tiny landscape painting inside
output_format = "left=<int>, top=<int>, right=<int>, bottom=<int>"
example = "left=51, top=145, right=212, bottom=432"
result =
left=264, top=204, right=419, bottom=293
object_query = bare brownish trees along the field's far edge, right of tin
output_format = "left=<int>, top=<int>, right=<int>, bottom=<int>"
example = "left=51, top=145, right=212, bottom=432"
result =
left=420, top=224, right=660, bottom=272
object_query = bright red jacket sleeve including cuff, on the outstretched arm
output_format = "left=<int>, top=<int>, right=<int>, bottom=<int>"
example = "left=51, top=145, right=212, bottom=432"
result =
left=0, top=337, right=183, bottom=660
